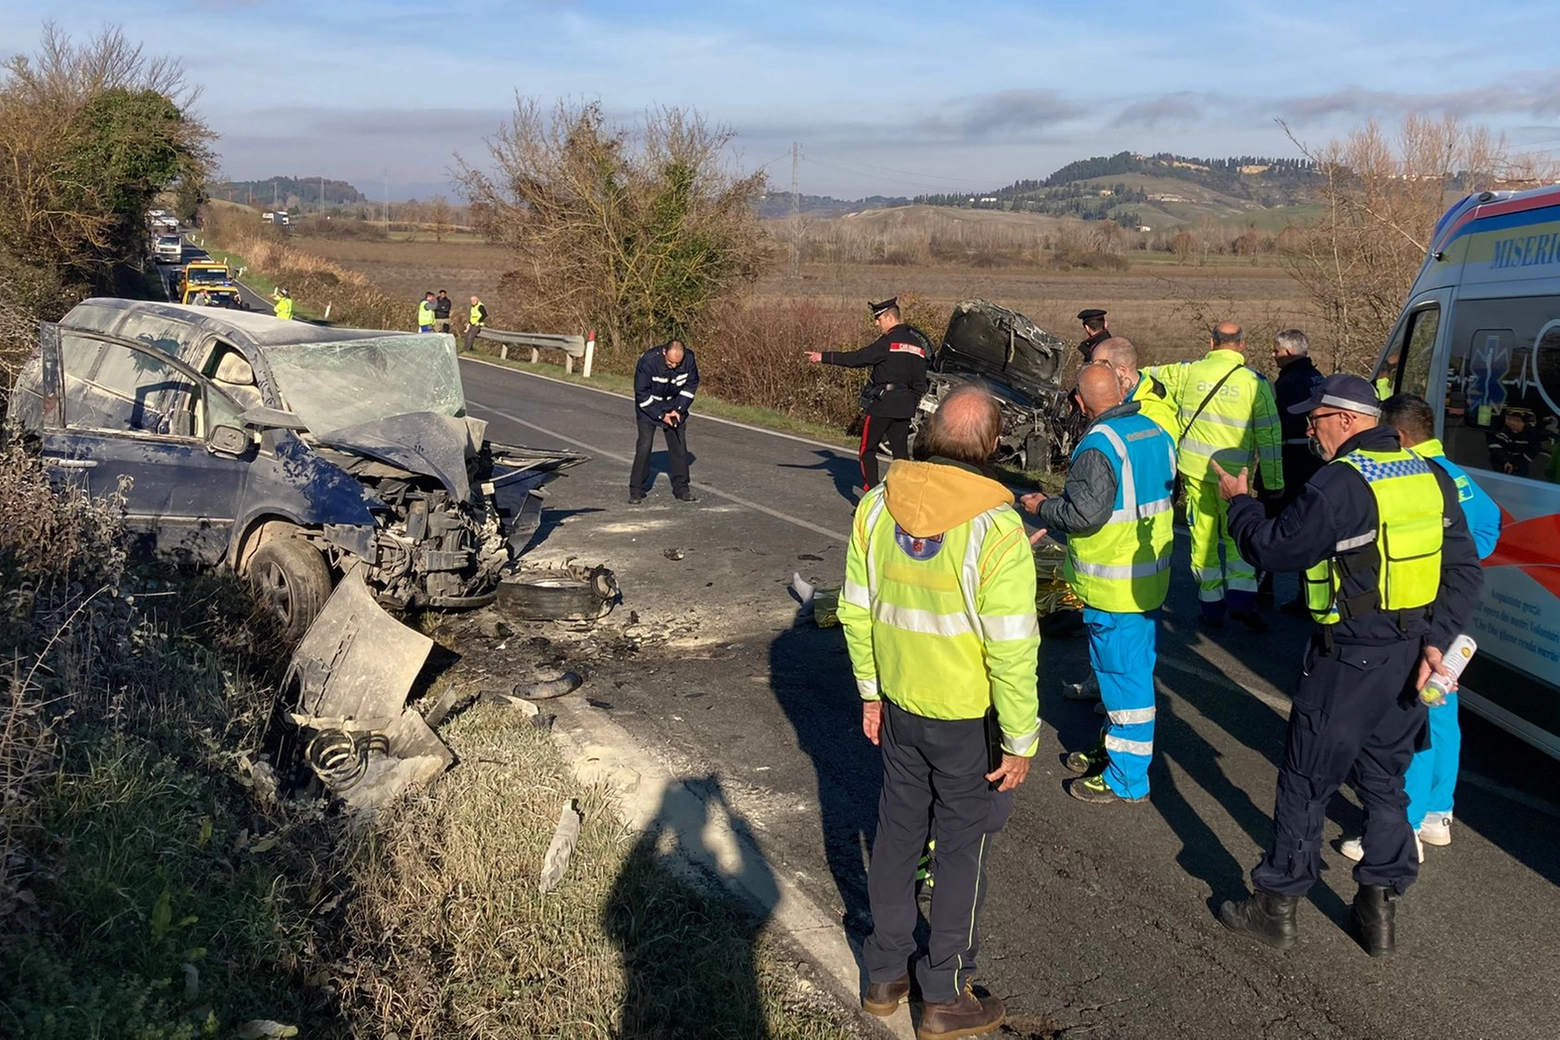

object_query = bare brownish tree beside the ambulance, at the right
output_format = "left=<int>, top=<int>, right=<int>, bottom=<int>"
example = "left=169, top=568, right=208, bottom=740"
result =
left=1279, top=114, right=1552, bottom=373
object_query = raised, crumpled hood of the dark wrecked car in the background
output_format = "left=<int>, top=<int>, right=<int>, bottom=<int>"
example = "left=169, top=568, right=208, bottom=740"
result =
left=933, top=299, right=1067, bottom=401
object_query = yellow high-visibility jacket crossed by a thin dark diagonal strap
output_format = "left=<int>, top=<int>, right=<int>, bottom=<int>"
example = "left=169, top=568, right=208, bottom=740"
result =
left=1143, top=348, right=1284, bottom=491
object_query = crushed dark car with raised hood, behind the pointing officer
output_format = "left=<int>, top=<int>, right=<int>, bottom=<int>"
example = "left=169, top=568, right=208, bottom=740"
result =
left=911, top=299, right=1072, bottom=471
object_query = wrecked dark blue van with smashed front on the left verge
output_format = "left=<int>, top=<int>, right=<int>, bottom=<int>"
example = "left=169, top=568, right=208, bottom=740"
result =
left=6, top=299, right=585, bottom=636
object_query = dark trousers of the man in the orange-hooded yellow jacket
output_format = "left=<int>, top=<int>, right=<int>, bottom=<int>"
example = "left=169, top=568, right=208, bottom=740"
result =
left=863, top=700, right=1012, bottom=1003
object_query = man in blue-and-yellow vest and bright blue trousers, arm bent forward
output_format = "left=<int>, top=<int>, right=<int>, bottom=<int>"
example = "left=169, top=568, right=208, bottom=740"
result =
left=1020, top=363, right=1175, bottom=805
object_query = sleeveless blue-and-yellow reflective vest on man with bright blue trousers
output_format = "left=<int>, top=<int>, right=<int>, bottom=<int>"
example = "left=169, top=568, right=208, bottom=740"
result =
left=1064, top=412, right=1175, bottom=614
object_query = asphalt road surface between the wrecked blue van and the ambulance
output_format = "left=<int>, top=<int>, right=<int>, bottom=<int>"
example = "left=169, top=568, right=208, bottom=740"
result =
left=463, top=362, right=1560, bottom=1040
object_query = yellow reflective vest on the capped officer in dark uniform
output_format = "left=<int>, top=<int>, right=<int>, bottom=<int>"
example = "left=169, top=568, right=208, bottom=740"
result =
left=1303, top=447, right=1446, bottom=625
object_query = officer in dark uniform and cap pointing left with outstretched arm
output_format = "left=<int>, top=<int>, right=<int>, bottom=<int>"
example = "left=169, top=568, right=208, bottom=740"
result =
left=807, top=296, right=931, bottom=491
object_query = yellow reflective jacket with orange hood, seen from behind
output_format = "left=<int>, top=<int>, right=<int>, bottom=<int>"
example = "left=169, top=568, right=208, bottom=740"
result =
left=839, top=460, right=1041, bottom=758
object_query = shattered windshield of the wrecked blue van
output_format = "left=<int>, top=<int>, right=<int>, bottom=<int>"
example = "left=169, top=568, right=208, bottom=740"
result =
left=265, top=334, right=466, bottom=433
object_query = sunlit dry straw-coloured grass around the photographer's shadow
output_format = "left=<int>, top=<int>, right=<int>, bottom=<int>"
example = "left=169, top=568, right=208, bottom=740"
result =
left=333, top=706, right=855, bottom=1040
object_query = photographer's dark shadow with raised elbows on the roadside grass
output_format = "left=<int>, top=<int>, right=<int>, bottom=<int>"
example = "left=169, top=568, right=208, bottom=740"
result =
left=602, top=775, right=783, bottom=1040
